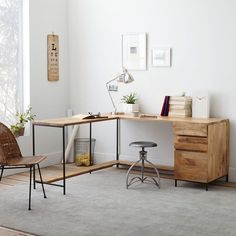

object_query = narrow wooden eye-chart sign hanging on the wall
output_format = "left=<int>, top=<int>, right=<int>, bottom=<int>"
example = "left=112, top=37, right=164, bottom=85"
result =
left=48, top=34, right=59, bottom=81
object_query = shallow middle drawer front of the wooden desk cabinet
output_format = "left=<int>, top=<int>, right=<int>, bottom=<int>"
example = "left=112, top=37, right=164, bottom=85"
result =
left=175, top=136, right=208, bottom=152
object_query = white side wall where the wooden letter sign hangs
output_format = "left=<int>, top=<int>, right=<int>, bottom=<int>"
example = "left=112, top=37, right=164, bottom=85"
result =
left=19, top=0, right=69, bottom=166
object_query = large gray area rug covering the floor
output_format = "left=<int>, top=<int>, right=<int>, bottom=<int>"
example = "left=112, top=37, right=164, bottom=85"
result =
left=0, top=168, right=236, bottom=236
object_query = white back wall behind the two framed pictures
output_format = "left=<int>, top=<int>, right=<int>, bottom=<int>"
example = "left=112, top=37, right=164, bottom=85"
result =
left=68, top=0, right=236, bottom=180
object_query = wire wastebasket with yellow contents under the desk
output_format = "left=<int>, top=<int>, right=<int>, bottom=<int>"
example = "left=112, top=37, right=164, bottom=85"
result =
left=74, top=138, right=96, bottom=166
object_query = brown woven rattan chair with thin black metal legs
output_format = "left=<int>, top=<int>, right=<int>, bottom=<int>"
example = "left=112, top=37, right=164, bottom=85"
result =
left=0, top=123, right=46, bottom=210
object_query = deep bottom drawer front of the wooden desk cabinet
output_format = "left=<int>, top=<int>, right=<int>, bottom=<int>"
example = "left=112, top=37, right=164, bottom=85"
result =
left=175, top=150, right=208, bottom=183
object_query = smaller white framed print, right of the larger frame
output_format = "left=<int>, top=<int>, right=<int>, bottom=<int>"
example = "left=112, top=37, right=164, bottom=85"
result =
left=152, top=47, right=171, bottom=67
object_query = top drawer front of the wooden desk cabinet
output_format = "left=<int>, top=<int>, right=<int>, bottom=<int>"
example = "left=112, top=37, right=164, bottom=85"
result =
left=173, top=122, right=207, bottom=137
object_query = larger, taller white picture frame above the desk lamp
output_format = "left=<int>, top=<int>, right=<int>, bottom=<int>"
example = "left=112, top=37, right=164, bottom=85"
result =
left=122, top=33, right=147, bottom=70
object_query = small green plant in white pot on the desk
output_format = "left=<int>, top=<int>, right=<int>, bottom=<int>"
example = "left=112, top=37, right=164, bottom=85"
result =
left=121, top=93, right=139, bottom=113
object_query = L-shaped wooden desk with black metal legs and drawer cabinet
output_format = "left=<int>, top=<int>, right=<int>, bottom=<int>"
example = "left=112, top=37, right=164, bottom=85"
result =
left=32, top=115, right=229, bottom=194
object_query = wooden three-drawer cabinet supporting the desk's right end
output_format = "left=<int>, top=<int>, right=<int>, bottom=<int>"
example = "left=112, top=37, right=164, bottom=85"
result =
left=173, top=121, right=229, bottom=187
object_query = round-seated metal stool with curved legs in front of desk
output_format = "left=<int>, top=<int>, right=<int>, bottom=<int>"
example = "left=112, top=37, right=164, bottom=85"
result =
left=126, top=141, right=160, bottom=189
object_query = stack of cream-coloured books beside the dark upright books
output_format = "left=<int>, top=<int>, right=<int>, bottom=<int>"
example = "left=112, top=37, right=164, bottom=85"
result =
left=168, top=96, right=192, bottom=117
